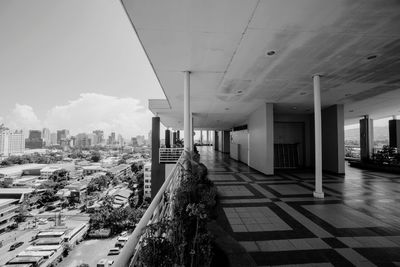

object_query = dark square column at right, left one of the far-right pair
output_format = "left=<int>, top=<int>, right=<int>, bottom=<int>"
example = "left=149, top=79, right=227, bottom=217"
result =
left=360, top=115, right=374, bottom=161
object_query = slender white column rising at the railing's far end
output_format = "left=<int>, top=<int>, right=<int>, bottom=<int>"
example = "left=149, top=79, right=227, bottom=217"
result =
left=183, top=71, right=192, bottom=151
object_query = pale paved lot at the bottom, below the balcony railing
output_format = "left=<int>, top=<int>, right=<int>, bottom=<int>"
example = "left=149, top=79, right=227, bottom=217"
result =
left=57, top=237, right=117, bottom=267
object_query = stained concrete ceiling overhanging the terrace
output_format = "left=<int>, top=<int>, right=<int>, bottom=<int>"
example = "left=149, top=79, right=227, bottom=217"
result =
left=122, top=0, right=400, bottom=129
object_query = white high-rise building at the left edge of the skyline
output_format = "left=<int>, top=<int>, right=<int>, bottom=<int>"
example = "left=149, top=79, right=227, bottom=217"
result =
left=0, top=125, right=25, bottom=157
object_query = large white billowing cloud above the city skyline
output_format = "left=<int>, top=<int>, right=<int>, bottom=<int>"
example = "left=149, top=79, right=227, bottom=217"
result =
left=44, top=93, right=152, bottom=138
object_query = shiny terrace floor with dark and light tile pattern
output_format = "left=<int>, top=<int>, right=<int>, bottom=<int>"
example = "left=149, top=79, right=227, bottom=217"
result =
left=199, top=147, right=400, bottom=266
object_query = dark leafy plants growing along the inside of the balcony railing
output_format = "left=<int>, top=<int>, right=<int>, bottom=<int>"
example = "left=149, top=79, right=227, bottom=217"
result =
left=139, top=153, right=217, bottom=267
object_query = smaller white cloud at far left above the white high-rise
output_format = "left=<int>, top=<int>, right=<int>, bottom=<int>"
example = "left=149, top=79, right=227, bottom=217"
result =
left=4, top=103, right=42, bottom=131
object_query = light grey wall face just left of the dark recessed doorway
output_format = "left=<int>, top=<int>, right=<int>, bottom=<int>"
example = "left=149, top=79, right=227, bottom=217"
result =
left=247, top=103, right=274, bottom=175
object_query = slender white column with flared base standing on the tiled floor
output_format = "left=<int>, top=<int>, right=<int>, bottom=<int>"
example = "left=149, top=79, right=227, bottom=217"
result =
left=313, top=74, right=324, bottom=198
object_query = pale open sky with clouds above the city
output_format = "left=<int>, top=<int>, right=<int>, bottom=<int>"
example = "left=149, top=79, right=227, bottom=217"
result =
left=0, top=0, right=165, bottom=138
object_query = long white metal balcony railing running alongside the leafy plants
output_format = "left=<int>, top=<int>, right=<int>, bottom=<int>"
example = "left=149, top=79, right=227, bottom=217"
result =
left=114, top=152, right=184, bottom=267
